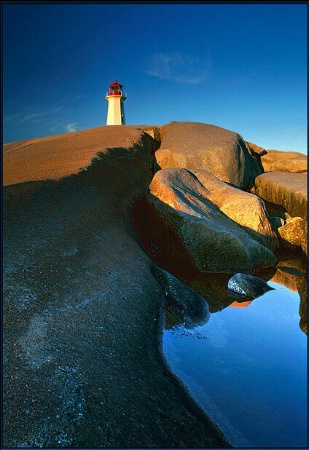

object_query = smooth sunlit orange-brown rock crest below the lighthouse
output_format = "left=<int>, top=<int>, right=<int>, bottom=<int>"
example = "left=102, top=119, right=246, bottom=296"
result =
left=3, top=125, right=160, bottom=186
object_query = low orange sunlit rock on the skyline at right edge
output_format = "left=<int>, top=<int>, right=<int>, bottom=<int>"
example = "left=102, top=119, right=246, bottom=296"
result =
left=261, top=150, right=308, bottom=173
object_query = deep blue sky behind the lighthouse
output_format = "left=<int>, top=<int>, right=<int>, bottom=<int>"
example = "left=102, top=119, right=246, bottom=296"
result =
left=1, top=2, right=308, bottom=153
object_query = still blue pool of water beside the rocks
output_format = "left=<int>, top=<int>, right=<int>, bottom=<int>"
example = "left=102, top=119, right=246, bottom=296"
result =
left=163, top=274, right=307, bottom=448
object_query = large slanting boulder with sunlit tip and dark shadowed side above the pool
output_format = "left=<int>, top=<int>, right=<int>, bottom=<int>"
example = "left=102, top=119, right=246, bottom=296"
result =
left=138, top=169, right=276, bottom=273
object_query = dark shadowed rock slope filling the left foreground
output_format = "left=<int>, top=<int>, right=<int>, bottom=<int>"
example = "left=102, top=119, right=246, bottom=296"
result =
left=3, top=129, right=229, bottom=448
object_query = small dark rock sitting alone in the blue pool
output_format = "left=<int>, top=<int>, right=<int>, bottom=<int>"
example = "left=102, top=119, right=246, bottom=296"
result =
left=227, top=273, right=273, bottom=298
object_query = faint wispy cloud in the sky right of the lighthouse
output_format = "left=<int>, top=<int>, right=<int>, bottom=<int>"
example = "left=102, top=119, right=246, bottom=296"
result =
left=145, top=53, right=209, bottom=84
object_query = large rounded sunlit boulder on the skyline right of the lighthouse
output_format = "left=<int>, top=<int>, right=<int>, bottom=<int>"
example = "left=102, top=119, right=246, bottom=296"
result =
left=156, top=122, right=263, bottom=189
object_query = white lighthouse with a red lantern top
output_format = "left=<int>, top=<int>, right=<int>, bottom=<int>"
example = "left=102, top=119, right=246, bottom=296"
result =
left=105, top=80, right=127, bottom=125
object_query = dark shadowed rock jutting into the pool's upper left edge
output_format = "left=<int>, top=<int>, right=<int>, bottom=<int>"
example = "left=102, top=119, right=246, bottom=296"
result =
left=151, top=265, right=210, bottom=329
